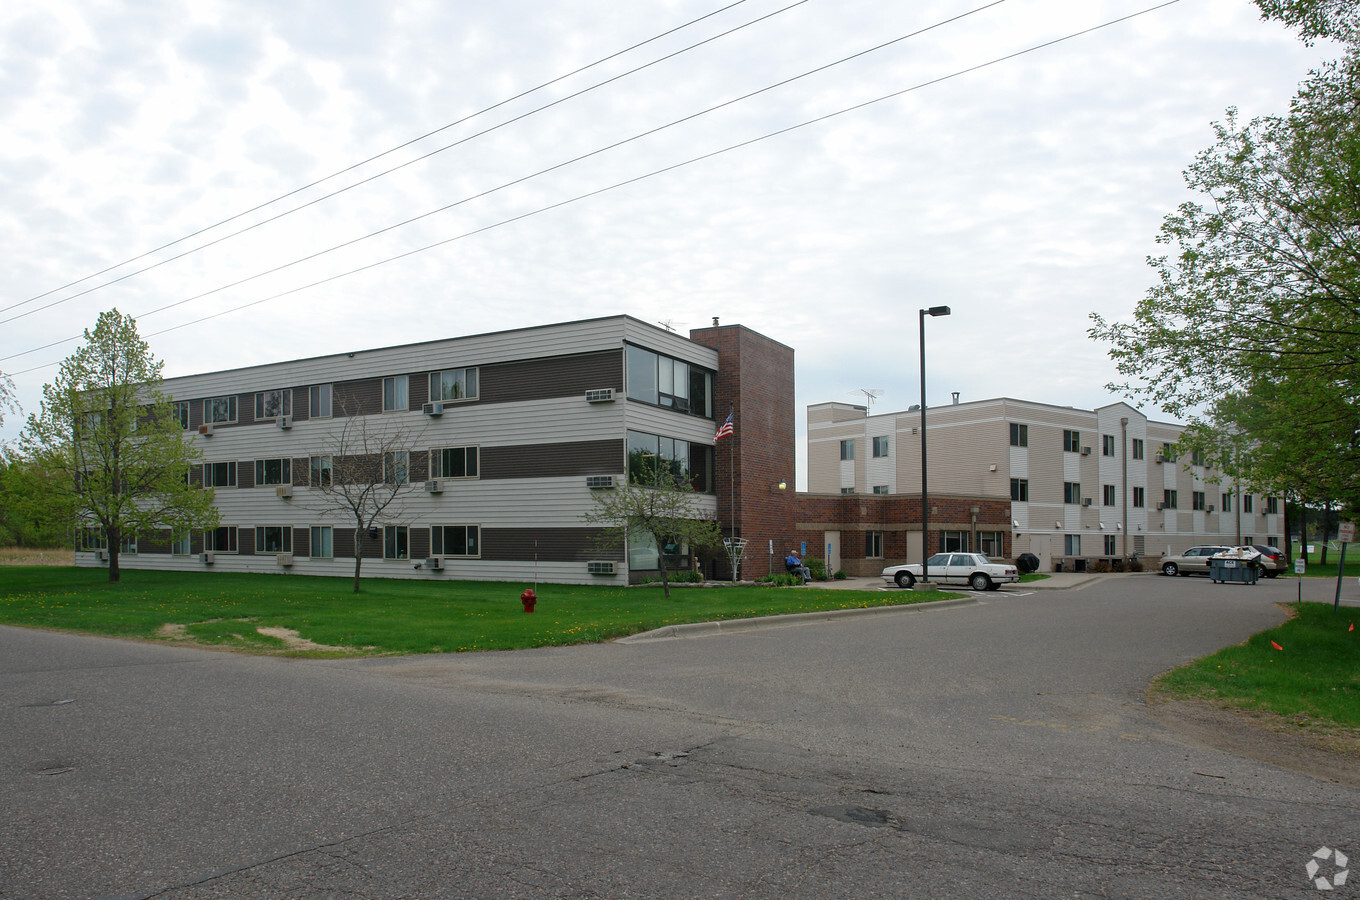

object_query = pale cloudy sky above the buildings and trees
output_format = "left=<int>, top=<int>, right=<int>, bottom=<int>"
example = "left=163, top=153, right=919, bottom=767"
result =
left=0, top=0, right=1336, bottom=484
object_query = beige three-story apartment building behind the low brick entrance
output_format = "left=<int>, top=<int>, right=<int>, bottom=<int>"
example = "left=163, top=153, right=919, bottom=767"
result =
left=808, top=397, right=1285, bottom=571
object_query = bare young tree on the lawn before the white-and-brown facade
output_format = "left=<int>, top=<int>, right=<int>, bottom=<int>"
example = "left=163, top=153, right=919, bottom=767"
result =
left=309, top=401, right=423, bottom=594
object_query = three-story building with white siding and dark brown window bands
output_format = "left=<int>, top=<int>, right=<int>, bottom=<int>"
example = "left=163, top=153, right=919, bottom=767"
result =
left=76, top=315, right=718, bottom=583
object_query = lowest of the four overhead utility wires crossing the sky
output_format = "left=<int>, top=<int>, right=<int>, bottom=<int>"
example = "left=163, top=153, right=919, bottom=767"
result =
left=0, top=0, right=1180, bottom=375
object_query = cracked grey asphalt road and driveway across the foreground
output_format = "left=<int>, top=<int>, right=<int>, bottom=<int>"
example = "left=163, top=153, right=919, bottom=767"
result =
left=0, top=576, right=1360, bottom=900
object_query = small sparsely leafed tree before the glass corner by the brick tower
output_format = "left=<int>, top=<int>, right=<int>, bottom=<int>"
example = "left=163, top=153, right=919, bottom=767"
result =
left=582, top=460, right=722, bottom=598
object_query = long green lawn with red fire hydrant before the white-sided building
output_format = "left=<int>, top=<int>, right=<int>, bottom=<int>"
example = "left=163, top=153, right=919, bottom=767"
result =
left=0, top=566, right=951, bottom=655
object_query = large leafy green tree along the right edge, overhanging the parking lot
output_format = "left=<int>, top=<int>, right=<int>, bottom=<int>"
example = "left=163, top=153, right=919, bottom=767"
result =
left=1089, top=40, right=1360, bottom=513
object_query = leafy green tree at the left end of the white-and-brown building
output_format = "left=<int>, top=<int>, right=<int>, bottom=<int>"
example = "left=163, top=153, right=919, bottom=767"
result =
left=19, top=310, right=218, bottom=582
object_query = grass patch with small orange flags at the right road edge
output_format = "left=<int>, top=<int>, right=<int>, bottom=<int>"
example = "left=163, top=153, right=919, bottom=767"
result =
left=1155, top=604, right=1360, bottom=727
